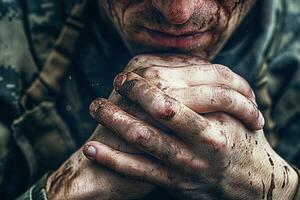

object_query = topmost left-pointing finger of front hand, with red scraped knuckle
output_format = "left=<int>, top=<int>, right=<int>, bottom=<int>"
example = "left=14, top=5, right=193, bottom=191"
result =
left=114, top=72, right=209, bottom=141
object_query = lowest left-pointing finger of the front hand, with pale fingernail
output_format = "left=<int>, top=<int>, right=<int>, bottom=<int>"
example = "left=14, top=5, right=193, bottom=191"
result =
left=83, top=141, right=181, bottom=187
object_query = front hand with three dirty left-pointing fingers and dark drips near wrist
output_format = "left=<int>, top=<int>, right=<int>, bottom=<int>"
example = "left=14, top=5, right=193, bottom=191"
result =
left=86, top=67, right=297, bottom=199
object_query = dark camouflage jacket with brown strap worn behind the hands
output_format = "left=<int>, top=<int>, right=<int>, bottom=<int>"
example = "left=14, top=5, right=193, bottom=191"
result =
left=0, top=0, right=300, bottom=199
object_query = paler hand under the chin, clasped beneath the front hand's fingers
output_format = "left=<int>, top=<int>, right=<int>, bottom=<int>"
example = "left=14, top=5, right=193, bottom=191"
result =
left=91, top=55, right=264, bottom=153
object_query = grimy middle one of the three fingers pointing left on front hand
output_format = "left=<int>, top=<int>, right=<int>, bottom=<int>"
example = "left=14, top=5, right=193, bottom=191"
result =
left=91, top=99, right=205, bottom=170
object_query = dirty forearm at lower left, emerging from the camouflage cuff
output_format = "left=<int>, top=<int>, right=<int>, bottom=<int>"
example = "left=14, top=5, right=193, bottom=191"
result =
left=46, top=149, right=153, bottom=200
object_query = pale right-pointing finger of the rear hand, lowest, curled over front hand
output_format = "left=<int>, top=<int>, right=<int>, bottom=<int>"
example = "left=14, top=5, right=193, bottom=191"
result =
left=166, top=85, right=264, bottom=130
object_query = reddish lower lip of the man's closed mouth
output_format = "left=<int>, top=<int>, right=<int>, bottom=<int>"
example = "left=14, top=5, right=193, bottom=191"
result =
left=147, top=29, right=205, bottom=49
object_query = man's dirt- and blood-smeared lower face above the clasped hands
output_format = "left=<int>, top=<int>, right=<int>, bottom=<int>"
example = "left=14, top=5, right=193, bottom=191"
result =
left=98, top=0, right=256, bottom=59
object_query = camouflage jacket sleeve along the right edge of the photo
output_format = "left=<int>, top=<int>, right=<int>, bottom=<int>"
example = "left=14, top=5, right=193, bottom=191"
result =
left=269, top=0, right=300, bottom=168
